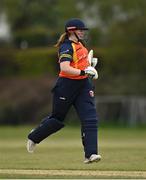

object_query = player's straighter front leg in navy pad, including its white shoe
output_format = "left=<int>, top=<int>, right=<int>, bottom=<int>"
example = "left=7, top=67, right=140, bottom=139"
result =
left=74, top=80, right=101, bottom=163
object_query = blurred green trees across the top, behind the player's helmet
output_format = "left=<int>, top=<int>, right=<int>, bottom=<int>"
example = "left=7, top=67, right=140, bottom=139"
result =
left=0, top=0, right=146, bottom=46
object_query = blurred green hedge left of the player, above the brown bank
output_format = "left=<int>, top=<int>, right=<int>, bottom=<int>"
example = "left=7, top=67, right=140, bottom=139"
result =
left=0, top=48, right=58, bottom=77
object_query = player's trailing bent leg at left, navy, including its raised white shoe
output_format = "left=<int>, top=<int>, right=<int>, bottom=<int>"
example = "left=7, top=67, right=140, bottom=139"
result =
left=27, top=79, right=81, bottom=152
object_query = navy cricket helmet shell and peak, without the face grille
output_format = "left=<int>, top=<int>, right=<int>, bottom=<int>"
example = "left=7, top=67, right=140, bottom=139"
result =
left=65, top=18, right=88, bottom=32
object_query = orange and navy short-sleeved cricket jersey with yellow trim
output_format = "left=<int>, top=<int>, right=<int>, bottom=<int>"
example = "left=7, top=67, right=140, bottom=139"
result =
left=59, top=39, right=89, bottom=79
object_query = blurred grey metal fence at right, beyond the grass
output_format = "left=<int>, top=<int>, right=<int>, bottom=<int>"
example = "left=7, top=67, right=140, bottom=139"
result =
left=96, top=96, right=146, bottom=126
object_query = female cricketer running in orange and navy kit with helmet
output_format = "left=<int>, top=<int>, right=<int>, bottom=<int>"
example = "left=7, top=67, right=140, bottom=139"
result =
left=27, top=18, right=101, bottom=164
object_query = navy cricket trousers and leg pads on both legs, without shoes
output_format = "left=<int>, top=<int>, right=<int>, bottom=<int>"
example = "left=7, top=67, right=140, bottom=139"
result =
left=28, top=77, right=98, bottom=158
